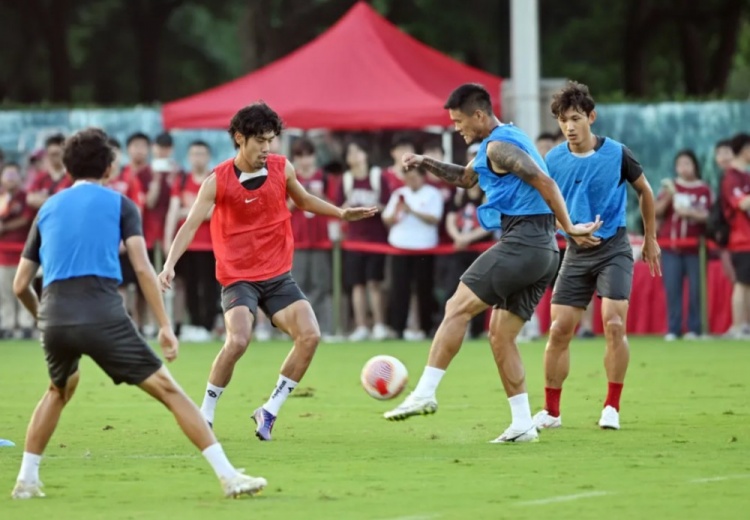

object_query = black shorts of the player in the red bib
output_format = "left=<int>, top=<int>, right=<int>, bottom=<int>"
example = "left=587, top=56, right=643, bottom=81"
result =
left=221, top=273, right=307, bottom=323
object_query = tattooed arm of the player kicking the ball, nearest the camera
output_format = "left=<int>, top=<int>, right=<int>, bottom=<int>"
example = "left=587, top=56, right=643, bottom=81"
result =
left=487, top=141, right=602, bottom=236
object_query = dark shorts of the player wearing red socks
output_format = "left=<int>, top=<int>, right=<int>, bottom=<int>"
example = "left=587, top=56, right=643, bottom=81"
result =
left=552, top=229, right=634, bottom=309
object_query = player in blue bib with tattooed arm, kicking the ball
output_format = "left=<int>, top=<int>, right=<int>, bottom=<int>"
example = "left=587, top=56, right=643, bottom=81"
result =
left=385, top=84, right=601, bottom=443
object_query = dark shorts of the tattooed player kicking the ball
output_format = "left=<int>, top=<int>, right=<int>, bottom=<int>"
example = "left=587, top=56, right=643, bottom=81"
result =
left=461, top=242, right=560, bottom=321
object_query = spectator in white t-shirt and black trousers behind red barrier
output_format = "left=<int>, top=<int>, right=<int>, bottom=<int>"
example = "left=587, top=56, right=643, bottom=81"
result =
left=383, top=169, right=443, bottom=340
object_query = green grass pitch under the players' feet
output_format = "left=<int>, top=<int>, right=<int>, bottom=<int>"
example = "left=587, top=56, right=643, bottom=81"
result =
left=0, top=338, right=750, bottom=520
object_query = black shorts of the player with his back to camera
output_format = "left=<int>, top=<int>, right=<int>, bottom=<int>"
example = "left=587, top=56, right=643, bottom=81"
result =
left=42, top=318, right=162, bottom=388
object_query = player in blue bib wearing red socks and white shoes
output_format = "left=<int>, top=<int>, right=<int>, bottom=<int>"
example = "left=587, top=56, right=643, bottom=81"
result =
left=534, top=82, right=661, bottom=430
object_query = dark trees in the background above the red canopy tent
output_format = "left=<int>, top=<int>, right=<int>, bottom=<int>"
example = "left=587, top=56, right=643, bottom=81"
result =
left=0, top=0, right=750, bottom=105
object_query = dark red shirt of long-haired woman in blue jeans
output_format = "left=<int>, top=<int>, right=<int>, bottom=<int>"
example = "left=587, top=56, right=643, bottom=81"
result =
left=659, top=178, right=712, bottom=254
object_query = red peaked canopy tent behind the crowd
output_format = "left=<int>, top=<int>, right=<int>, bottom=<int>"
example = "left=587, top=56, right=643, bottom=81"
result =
left=163, top=2, right=502, bottom=130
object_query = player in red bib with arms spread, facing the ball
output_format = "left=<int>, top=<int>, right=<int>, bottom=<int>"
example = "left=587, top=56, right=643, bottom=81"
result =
left=159, top=102, right=377, bottom=441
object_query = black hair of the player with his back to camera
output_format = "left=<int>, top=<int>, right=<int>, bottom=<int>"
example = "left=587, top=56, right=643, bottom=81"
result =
left=63, top=128, right=115, bottom=179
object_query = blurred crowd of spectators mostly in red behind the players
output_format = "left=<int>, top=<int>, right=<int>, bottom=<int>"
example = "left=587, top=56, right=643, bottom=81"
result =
left=0, top=127, right=750, bottom=342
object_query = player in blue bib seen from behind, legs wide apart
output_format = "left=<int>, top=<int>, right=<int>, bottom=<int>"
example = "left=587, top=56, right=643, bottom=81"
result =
left=12, top=129, right=266, bottom=499
